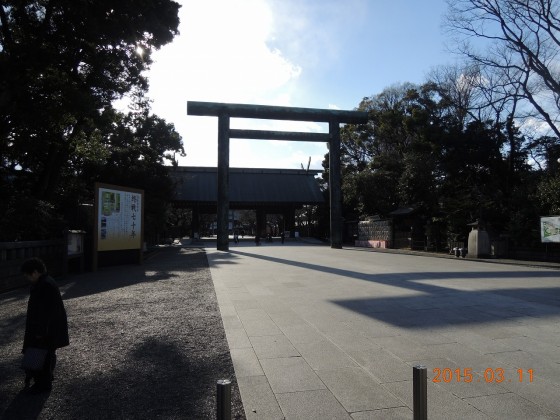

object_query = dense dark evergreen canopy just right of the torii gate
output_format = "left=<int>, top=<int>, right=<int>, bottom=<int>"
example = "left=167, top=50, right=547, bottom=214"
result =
left=334, top=82, right=537, bottom=248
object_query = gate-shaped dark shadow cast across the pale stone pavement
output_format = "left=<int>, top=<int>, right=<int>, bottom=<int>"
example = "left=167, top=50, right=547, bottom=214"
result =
left=226, top=251, right=560, bottom=328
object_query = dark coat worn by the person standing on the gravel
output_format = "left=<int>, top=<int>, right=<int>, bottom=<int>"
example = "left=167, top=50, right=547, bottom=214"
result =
left=23, top=274, right=70, bottom=350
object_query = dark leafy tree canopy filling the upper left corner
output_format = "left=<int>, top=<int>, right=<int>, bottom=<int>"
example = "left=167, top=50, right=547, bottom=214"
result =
left=0, top=0, right=184, bottom=239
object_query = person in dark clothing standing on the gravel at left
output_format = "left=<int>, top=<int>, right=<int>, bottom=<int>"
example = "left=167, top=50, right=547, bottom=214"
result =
left=21, top=258, right=70, bottom=393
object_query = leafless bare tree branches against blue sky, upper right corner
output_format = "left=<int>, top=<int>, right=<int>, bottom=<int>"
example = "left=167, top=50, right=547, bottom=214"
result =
left=446, top=0, right=560, bottom=137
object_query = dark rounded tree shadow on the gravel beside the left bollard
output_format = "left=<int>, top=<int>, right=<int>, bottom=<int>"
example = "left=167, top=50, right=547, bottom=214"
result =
left=52, top=337, right=243, bottom=419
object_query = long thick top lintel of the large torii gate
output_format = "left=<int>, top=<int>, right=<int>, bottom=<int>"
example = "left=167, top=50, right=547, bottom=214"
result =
left=187, top=101, right=368, bottom=124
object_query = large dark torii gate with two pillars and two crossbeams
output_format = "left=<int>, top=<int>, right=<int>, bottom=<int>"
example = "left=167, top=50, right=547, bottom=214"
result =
left=187, top=101, right=368, bottom=251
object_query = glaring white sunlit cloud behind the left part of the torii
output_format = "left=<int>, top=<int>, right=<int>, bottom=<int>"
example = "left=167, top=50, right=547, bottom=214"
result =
left=144, top=0, right=327, bottom=168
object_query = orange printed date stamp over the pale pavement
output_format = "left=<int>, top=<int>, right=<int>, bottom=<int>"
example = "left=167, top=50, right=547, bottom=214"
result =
left=432, top=368, right=533, bottom=384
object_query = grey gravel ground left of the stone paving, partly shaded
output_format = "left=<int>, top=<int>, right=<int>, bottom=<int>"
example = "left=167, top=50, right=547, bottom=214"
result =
left=0, top=248, right=245, bottom=420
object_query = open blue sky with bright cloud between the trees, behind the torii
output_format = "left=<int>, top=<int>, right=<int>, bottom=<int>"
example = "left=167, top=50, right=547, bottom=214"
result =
left=144, top=0, right=455, bottom=169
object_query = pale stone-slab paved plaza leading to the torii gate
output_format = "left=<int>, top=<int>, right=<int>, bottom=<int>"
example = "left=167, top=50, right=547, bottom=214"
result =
left=206, top=243, right=560, bottom=420
